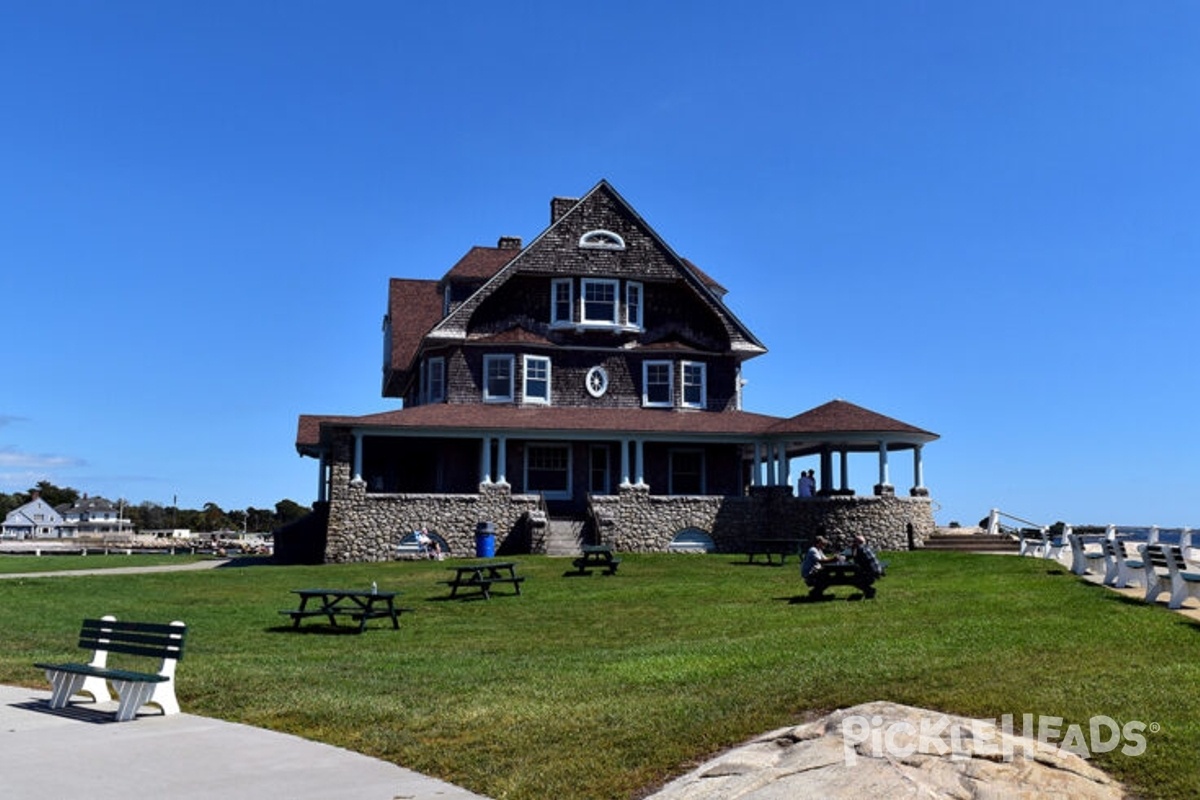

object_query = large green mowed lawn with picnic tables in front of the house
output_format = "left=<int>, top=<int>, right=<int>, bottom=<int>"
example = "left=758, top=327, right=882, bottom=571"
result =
left=0, top=553, right=1200, bottom=800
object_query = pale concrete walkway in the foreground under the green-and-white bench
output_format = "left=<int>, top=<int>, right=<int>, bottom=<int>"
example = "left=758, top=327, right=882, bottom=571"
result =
left=0, top=686, right=486, bottom=800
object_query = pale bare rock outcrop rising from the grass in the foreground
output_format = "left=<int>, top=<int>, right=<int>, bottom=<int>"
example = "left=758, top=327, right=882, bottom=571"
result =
left=652, top=702, right=1126, bottom=800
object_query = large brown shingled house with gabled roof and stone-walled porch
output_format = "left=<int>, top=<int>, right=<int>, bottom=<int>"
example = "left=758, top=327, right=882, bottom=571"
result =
left=285, top=181, right=937, bottom=561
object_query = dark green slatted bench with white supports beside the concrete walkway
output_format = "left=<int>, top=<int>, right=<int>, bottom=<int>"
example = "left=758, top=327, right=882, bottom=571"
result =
left=34, top=616, right=187, bottom=722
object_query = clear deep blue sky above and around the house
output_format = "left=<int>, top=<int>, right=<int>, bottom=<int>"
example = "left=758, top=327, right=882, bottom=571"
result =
left=0, top=0, right=1200, bottom=527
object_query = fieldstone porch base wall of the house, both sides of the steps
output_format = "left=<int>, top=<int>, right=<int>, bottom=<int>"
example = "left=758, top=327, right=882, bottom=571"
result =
left=325, top=437, right=936, bottom=563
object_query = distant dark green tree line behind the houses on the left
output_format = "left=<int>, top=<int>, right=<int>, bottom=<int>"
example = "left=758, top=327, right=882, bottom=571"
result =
left=0, top=481, right=312, bottom=533
